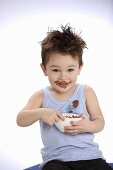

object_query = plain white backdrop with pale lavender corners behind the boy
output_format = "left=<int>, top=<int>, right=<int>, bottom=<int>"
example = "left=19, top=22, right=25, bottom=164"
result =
left=0, top=0, right=113, bottom=170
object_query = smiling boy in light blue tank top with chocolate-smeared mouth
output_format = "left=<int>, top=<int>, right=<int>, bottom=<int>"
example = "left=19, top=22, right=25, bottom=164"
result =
left=17, top=25, right=112, bottom=170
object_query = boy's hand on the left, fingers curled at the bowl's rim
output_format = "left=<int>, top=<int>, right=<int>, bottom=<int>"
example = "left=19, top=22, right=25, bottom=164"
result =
left=40, top=109, right=65, bottom=125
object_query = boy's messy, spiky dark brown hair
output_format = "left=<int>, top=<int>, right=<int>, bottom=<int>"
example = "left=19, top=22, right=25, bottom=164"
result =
left=41, top=25, right=87, bottom=67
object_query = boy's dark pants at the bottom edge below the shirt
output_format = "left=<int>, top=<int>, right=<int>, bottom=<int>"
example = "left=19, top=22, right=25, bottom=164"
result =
left=43, top=158, right=112, bottom=170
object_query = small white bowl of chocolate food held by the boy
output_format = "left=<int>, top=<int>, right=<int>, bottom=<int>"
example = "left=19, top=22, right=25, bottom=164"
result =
left=55, top=113, right=82, bottom=132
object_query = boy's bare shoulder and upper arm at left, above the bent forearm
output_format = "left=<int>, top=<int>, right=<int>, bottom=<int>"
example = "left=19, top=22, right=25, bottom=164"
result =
left=23, top=90, right=44, bottom=110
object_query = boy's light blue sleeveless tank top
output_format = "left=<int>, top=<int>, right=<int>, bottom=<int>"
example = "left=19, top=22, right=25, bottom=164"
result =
left=40, top=84, right=103, bottom=167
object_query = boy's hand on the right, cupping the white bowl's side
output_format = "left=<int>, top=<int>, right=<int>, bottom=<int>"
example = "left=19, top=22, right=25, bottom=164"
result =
left=64, top=114, right=91, bottom=135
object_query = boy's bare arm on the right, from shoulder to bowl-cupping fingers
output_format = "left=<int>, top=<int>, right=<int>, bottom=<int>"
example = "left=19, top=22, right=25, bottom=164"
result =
left=65, top=86, right=105, bottom=134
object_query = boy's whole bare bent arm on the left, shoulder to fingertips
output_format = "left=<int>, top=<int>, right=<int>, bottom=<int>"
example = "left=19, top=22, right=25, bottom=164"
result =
left=17, top=91, right=64, bottom=127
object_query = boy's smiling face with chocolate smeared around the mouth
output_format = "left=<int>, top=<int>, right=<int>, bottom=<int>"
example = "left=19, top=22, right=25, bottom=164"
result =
left=41, top=53, right=82, bottom=92
